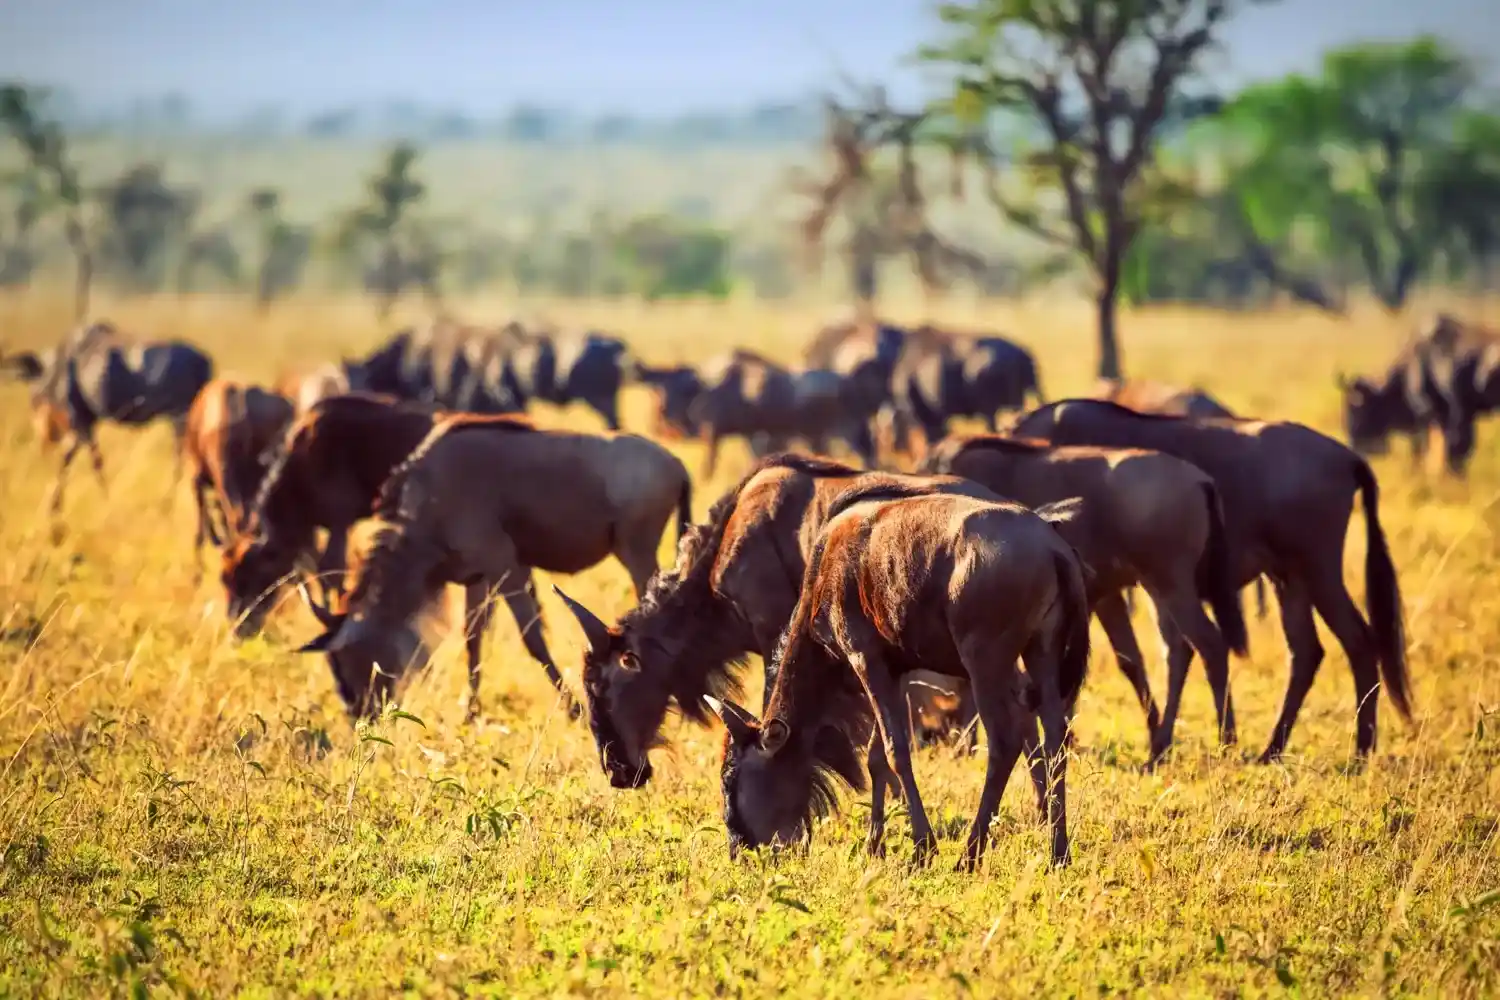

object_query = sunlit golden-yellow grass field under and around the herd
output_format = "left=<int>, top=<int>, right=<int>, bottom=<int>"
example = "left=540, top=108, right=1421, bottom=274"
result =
left=0, top=292, right=1500, bottom=997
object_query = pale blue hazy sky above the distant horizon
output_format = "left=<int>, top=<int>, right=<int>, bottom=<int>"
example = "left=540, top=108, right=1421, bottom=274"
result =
left=0, top=0, right=1500, bottom=112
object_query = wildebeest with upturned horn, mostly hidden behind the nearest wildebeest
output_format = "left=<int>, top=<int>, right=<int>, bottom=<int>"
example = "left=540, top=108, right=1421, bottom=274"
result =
left=558, top=454, right=995, bottom=789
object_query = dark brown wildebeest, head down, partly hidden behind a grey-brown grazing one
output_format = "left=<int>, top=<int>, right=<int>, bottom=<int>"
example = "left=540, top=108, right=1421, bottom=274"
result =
left=222, top=393, right=480, bottom=639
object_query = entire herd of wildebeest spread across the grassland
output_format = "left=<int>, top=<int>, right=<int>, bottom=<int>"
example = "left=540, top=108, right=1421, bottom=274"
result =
left=3, top=313, right=1500, bottom=868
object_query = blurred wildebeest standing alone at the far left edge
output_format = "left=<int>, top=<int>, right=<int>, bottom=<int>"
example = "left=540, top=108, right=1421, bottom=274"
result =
left=6, top=322, right=213, bottom=514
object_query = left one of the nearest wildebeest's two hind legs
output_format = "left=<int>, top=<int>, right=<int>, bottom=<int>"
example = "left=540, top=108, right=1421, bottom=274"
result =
left=959, top=642, right=1038, bottom=871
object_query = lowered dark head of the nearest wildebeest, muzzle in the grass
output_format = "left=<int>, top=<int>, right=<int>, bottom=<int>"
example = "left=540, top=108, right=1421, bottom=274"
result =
left=708, top=699, right=815, bottom=855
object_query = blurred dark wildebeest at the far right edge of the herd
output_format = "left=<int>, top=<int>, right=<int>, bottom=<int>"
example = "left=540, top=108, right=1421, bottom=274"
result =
left=1338, top=313, right=1500, bottom=477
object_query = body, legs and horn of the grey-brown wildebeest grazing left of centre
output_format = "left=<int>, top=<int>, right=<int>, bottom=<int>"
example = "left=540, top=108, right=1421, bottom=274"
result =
left=295, top=420, right=692, bottom=718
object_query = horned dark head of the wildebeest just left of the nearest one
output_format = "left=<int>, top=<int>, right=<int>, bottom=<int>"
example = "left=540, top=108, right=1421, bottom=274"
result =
left=552, top=585, right=672, bottom=789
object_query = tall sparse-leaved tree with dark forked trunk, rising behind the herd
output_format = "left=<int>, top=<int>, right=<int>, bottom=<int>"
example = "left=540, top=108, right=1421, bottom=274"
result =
left=920, top=0, right=1268, bottom=378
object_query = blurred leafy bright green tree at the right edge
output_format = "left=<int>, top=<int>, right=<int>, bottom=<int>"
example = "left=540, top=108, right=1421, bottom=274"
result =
left=1214, top=37, right=1500, bottom=312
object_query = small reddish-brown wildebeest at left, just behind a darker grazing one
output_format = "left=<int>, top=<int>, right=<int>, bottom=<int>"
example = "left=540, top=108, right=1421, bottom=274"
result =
left=183, top=378, right=293, bottom=570
